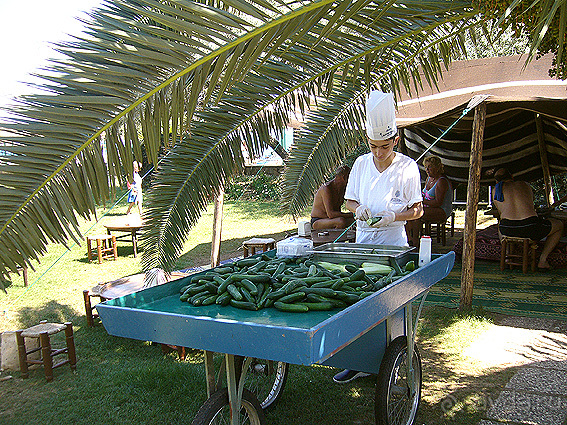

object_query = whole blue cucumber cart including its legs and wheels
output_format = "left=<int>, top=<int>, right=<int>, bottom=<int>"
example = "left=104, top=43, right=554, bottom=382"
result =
left=97, top=248, right=455, bottom=425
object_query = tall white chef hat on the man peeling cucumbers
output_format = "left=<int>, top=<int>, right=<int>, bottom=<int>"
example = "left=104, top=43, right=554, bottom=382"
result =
left=366, top=90, right=398, bottom=140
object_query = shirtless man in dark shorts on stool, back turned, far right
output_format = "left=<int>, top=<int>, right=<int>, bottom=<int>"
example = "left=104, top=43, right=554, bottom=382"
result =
left=494, top=168, right=563, bottom=269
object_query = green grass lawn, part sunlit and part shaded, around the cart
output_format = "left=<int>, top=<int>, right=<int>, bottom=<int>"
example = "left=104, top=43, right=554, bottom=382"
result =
left=0, top=201, right=512, bottom=425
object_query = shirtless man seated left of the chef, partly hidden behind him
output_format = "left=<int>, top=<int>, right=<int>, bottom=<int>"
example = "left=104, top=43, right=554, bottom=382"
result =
left=311, top=165, right=354, bottom=230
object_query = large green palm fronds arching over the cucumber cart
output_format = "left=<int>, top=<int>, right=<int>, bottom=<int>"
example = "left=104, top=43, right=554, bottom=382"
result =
left=0, top=0, right=564, bottom=280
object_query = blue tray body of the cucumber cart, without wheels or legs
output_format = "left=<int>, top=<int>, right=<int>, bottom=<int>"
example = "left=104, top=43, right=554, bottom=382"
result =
left=97, top=252, right=455, bottom=373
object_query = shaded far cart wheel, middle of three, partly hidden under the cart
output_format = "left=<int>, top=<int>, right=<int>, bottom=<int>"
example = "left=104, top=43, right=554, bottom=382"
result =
left=235, top=356, right=289, bottom=409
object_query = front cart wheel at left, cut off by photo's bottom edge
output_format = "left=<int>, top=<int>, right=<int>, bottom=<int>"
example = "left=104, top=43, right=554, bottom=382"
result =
left=191, top=388, right=266, bottom=425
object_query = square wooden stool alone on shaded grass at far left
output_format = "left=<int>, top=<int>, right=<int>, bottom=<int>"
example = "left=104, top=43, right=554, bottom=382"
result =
left=16, top=320, right=77, bottom=382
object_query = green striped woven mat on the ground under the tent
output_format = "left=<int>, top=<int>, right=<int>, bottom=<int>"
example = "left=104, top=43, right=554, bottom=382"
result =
left=426, top=258, right=567, bottom=320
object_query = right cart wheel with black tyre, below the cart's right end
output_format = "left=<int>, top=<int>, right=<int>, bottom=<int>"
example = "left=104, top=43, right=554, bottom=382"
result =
left=374, top=336, right=421, bottom=425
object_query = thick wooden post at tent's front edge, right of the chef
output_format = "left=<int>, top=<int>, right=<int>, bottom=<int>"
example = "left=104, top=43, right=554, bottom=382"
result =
left=460, top=102, right=486, bottom=310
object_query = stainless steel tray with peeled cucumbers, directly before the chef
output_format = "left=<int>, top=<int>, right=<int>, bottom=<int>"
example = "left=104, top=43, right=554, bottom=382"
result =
left=307, top=242, right=415, bottom=264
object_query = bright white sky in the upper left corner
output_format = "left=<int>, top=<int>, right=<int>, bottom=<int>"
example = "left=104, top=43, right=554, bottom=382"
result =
left=0, top=0, right=102, bottom=115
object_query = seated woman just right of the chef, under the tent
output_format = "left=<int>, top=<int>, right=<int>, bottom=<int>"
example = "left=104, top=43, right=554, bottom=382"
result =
left=406, top=155, right=453, bottom=246
